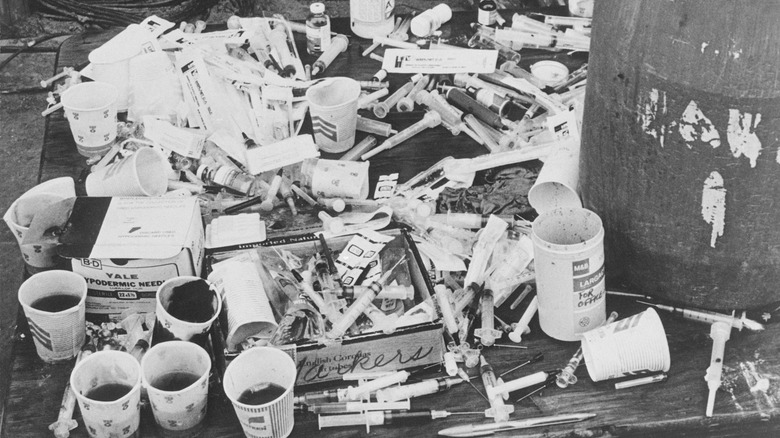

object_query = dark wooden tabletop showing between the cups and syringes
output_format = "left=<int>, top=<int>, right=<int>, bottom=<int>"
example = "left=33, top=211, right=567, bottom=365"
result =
left=2, top=9, right=780, bottom=437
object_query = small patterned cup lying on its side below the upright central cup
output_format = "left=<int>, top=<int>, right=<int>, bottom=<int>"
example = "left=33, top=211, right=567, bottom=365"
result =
left=301, top=158, right=370, bottom=199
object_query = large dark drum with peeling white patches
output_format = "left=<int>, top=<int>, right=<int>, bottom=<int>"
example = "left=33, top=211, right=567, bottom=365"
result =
left=580, top=0, right=780, bottom=310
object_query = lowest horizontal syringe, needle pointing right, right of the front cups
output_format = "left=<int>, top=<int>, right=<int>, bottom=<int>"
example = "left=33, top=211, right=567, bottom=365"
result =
left=319, top=409, right=482, bottom=430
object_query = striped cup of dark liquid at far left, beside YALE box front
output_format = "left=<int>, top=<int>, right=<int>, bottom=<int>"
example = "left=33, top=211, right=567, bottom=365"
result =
left=19, top=270, right=87, bottom=362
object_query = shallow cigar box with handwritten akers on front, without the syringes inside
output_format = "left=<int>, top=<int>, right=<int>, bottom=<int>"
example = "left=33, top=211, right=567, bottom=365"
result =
left=207, top=230, right=446, bottom=386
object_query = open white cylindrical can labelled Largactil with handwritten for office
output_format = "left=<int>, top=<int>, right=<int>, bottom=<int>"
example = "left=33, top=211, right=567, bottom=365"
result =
left=532, top=208, right=607, bottom=341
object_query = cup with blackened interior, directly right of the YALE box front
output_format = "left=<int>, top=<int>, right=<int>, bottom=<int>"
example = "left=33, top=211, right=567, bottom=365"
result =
left=152, top=276, right=222, bottom=347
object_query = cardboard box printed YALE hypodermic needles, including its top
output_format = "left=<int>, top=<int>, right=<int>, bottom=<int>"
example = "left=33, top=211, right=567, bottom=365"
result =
left=58, top=197, right=203, bottom=322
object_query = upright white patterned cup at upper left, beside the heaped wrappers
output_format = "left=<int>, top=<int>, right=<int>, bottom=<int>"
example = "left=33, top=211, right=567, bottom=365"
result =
left=60, top=82, right=118, bottom=157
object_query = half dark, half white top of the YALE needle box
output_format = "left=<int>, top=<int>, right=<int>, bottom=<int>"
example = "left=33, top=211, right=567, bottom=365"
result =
left=58, top=197, right=200, bottom=259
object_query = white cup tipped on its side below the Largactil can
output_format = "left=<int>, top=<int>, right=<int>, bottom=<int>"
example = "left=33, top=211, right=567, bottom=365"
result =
left=582, top=308, right=671, bottom=382
